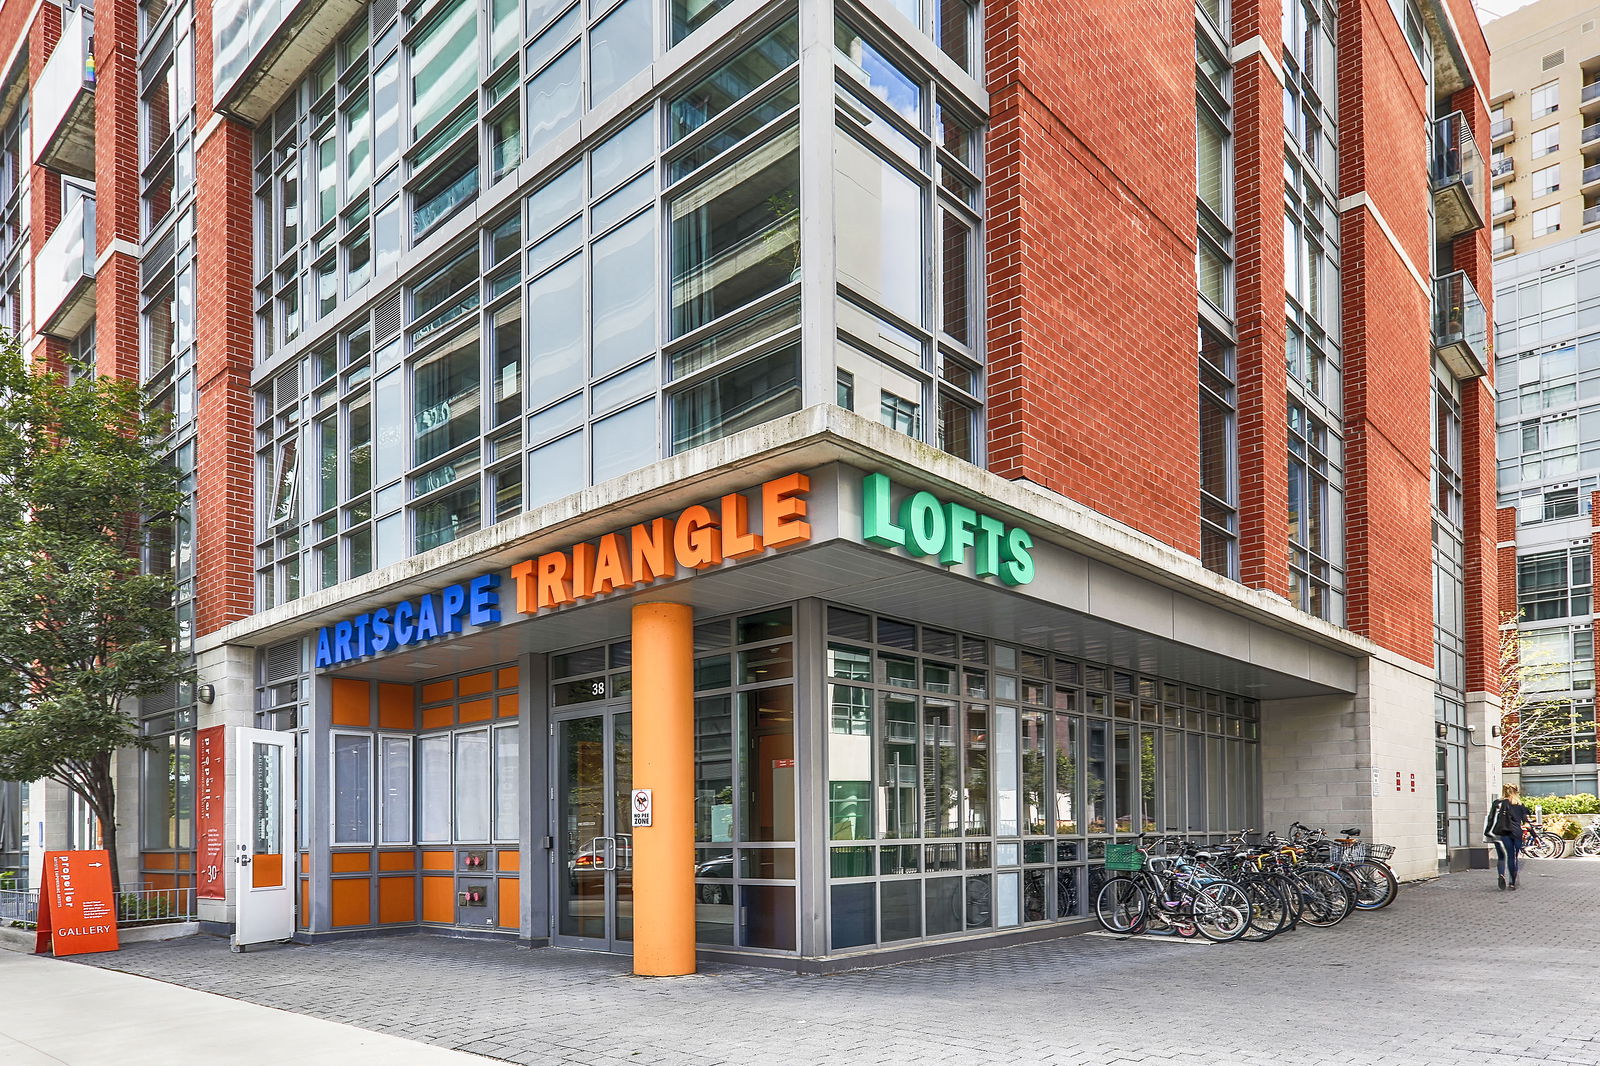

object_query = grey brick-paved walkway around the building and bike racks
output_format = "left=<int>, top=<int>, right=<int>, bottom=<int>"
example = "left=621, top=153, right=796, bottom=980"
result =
left=75, top=860, right=1600, bottom=1066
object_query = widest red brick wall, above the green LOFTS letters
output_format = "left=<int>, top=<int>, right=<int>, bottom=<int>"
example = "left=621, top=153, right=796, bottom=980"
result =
left=986, top=0, right=1200, bottom=552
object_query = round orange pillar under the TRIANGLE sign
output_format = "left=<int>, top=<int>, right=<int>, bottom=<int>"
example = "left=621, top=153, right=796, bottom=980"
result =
left=624, top=603, right=694, bottom=976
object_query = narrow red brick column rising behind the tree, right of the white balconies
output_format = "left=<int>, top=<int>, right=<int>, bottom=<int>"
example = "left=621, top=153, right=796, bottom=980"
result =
left=94, top=3, right=139, bottom=378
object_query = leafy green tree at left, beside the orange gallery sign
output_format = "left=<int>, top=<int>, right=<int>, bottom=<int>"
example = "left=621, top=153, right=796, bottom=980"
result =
left=0, top=338, right=190, bottom=890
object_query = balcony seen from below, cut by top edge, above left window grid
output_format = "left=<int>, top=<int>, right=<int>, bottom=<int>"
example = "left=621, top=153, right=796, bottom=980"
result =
left=211, top=0, right=368, bottom=125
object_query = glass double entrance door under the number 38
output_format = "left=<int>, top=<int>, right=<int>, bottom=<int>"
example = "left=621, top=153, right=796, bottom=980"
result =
left=552, top=709, right=634, bottom=952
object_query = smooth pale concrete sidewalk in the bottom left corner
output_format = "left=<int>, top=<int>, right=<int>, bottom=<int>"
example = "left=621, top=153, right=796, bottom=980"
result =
left=0, top=951, right=488, bottom=1066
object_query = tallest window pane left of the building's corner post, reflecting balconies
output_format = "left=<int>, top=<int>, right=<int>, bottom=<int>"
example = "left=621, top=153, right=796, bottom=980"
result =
left=670, top=128, right=800, bottom=336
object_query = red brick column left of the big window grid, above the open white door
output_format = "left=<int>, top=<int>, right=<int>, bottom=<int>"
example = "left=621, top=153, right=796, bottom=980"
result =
left=195, top=5, right=256, bottom=634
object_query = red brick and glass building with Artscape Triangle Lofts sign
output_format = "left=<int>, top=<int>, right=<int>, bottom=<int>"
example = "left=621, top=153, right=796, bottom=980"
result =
left=0, top=0, right=1499, bottom=973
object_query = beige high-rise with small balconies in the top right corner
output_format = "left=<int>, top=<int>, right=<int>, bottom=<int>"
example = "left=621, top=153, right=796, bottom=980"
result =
left=1483, top=0, right=1600, bottom=256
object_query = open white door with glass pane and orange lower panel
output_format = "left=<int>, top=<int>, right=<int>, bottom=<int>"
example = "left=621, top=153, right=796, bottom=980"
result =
left=232, top=728, right=299, bottom=951
